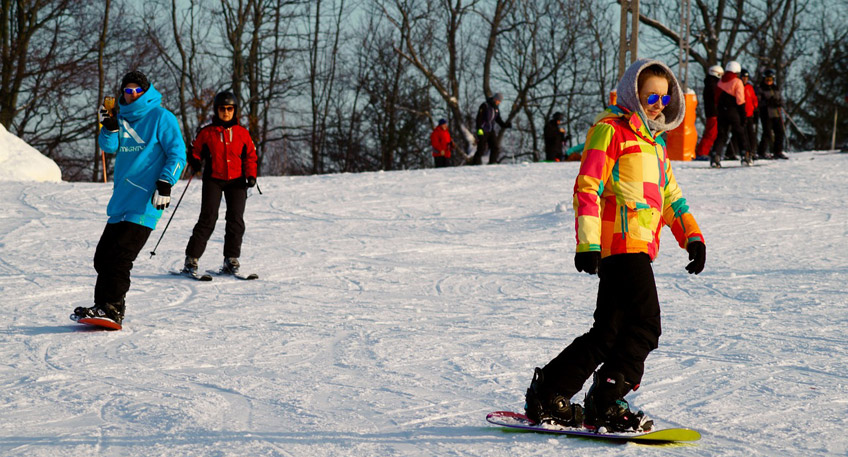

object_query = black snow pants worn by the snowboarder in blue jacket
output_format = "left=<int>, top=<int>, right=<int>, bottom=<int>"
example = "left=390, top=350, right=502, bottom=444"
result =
left=94, top=221, right=152, bottom=306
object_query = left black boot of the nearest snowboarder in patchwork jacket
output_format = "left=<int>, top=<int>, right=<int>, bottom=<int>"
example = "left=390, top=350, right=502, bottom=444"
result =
left=524, top=368, right=583, bottom=427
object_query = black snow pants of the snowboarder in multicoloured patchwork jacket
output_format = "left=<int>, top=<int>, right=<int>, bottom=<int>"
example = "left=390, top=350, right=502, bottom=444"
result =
left=543, top=253, right=662, bottom=398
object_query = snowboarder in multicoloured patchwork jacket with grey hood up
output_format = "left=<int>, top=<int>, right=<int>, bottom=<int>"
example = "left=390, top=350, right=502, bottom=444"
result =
left=526, top=59, right=706, bottom=432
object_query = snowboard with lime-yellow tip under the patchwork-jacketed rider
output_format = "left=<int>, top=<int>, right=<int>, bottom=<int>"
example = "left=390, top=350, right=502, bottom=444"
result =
left=486, top=411, right=701, bottom=443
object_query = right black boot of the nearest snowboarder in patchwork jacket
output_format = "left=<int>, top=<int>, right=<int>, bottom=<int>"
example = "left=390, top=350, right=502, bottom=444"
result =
left=583, top=372, right=654, bottom=433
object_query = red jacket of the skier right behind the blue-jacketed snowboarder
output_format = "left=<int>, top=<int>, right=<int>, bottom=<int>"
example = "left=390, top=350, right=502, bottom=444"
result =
left=191, top=124, right=256, bottom=181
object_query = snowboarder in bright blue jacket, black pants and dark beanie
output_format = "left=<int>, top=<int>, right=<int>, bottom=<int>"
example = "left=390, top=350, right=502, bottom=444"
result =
left=74, top=71, right=186, bottom=327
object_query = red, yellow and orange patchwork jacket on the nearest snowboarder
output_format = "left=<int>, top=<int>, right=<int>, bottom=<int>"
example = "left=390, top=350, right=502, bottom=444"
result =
left=574, top=106, right=704, bottom=260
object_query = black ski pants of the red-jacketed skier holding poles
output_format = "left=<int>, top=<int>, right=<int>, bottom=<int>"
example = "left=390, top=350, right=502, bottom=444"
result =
left=185, top=178, right=247, bottom=259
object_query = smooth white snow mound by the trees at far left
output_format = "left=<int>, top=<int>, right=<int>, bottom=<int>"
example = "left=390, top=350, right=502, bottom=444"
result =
left=0, top=124, right=62, bottom=182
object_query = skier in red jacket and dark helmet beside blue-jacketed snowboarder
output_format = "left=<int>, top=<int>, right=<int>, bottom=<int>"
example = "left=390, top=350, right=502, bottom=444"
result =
left=183, top=92, right=256, bottom=275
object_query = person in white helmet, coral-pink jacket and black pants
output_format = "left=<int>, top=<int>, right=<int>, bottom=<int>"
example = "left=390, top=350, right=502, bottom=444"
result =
left=710, top=60, right=752, bottom=168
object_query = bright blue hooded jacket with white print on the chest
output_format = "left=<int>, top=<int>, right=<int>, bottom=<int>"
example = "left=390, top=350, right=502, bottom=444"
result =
left=100, top=84, right=186, bottom=229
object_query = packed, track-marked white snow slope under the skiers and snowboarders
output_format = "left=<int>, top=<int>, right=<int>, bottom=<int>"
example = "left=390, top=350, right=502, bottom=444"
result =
left=0, top=152, right=848, bottom=457
